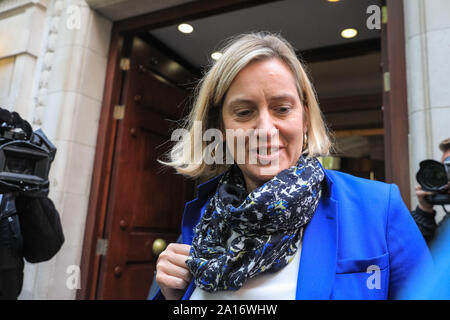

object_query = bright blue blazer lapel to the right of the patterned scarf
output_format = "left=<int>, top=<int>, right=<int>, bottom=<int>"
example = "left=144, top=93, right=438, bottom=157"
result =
left=296, top=174, right=338, bottom=300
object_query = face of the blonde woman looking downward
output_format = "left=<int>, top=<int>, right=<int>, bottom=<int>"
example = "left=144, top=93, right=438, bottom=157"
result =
left=222, top=58, right=306, bottom=191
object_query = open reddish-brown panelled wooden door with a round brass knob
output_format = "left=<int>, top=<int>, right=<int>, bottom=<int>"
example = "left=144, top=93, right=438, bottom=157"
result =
left=96, top=37, right=194, bottom=299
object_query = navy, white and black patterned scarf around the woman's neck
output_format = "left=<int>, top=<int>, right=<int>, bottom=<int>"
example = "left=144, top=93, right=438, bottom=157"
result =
left=186, top=157, right=325, bottom=292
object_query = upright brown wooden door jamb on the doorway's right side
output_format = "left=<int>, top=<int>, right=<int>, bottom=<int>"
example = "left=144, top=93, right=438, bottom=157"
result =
left=381, top=0, right=411, bottom=207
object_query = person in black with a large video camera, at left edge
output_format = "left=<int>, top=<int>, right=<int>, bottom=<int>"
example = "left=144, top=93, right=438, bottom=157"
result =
left=0, top=108, right=64, bottom=300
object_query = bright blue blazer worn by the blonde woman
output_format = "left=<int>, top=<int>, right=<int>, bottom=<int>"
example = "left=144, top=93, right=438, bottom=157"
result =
left=153, top=170, right=432, bottom=300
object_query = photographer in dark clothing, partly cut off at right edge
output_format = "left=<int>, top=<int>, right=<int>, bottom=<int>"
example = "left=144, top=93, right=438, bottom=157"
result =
left=411, top=138, right=450, bottom=245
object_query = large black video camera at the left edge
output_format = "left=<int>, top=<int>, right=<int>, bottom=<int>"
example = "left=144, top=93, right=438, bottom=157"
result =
left=0, top=126, right=56, bottom=196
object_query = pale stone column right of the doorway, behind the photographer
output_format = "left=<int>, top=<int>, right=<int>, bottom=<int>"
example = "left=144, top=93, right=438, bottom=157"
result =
left=404, top=0, right=450, bottom=220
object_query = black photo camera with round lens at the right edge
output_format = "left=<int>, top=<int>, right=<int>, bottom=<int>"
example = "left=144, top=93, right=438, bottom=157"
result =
left=416, top=157, right=450, bottom=205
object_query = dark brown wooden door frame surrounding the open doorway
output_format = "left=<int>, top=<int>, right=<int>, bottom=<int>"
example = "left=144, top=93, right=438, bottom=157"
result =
left=76, top=0, right=410, bottom=300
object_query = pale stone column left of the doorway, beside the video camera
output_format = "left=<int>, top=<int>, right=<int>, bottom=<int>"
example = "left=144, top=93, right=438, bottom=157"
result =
left=24, top=0, right=112, bottom=299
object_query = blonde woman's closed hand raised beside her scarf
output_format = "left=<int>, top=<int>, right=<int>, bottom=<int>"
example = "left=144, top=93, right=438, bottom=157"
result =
left=156, top=243, right=192, bottom=300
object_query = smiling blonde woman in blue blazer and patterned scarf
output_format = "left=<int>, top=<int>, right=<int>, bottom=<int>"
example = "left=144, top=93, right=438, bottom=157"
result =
left=154, top=33, right=430, bottom=299
